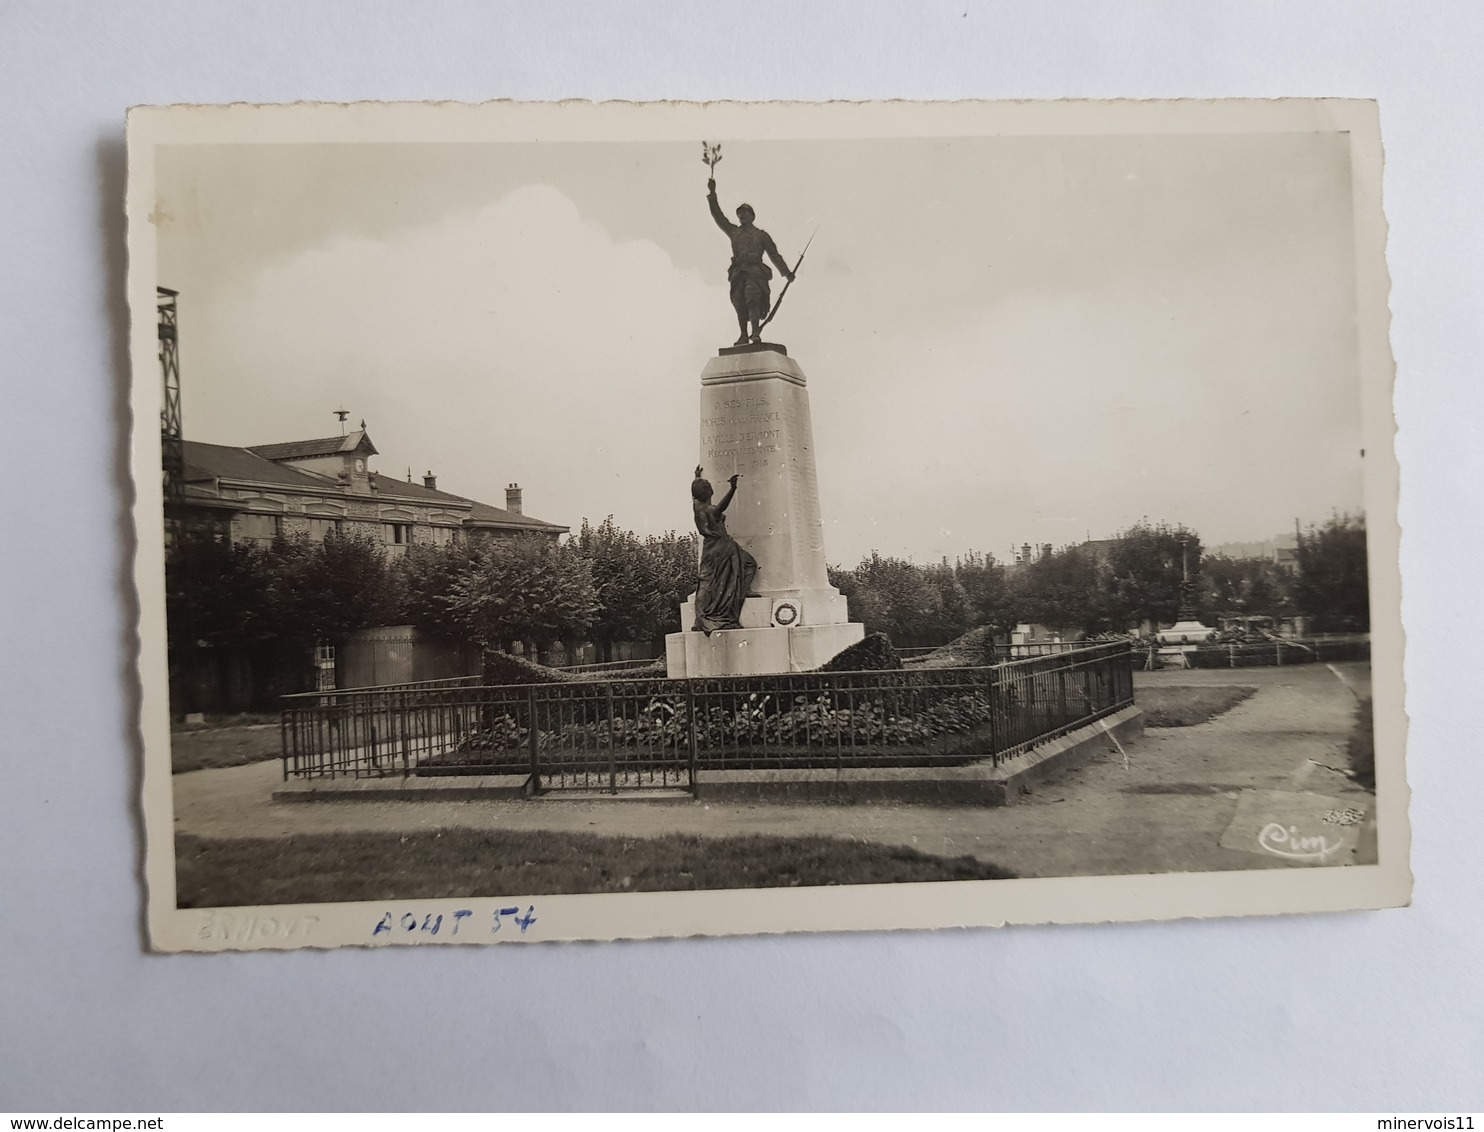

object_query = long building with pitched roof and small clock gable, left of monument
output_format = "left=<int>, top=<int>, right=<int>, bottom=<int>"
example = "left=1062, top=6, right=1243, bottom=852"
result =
left=183, top=427, right=570, bottom=556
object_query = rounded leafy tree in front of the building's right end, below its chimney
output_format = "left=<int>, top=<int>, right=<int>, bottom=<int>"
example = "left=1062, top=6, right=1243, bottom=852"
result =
left=450, top=536, right=598, bottom=650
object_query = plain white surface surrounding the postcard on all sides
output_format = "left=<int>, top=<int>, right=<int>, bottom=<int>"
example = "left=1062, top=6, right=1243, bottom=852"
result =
left=0, top=0, right=1484, bottom=1111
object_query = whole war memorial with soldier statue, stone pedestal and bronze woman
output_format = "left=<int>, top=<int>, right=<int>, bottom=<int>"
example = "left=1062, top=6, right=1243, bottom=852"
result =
left=665, top=144, right=865, bottom=677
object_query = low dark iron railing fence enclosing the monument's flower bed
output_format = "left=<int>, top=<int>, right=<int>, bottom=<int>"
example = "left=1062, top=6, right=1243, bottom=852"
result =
left=282, top=642, right=1134, bottom=791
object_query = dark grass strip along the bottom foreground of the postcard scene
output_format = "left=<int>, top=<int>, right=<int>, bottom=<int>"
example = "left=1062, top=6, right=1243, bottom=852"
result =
left=175, top=829, right=1015, bottom=908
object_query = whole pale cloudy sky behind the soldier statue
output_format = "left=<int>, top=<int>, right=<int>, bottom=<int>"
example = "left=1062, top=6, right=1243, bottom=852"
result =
left=156, top=134, right=1361, bottom=564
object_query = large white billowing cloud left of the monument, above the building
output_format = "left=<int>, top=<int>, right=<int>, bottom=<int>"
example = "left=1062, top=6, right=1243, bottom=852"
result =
left=187, top=185, right=730, bottom=531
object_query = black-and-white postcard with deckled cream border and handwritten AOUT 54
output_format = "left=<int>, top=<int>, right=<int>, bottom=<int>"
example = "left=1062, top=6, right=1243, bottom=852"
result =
left=128, top=99, right=1411, bottom=951
